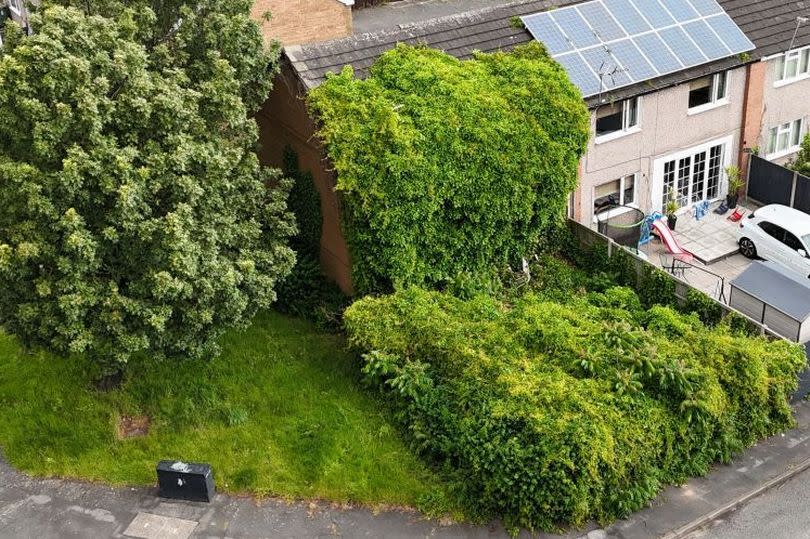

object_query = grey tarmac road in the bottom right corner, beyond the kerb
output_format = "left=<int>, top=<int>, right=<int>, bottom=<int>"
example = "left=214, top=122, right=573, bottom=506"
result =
left=688, top=470, right=810, bottom=539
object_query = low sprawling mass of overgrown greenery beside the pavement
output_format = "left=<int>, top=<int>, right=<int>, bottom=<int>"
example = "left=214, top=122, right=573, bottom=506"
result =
left=344, top=288, right=806, bottom=530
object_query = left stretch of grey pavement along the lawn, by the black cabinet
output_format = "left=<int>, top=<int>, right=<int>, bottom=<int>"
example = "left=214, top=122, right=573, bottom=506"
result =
left=0, top=460, right=508, bottom=539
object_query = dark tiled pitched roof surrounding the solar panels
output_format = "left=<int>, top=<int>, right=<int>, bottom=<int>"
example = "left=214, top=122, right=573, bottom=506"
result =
left=285, top=0, right=810, bottom=106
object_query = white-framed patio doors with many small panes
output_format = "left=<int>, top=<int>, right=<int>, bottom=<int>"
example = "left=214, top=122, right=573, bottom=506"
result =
left=653, top=136, right=731, bottom=211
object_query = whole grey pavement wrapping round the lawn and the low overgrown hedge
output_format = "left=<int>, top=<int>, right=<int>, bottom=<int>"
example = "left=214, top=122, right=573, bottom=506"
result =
left=0, top=401, right=810, bottom=539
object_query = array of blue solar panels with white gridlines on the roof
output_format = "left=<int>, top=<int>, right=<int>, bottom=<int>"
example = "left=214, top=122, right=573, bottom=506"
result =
left=523, top=0, right=754, bottom=97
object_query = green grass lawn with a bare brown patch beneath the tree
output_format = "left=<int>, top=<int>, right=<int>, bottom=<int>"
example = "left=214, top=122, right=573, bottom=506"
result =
left=0, top=313, right=442, bottom=505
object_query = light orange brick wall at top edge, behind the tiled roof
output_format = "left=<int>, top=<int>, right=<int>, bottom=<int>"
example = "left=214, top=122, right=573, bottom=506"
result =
left=253, top=0, right=354, bottom=46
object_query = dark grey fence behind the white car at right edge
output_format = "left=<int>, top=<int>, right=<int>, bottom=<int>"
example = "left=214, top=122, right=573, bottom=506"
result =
left=748, top=155, right=810, bottom=213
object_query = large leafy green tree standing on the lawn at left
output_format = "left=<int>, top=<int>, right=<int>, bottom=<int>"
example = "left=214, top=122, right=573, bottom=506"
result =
left=0, top=0, right=295, bottom=368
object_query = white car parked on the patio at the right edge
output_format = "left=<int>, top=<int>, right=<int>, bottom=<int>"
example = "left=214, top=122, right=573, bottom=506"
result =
left=737, top=204, right=810, bottom=277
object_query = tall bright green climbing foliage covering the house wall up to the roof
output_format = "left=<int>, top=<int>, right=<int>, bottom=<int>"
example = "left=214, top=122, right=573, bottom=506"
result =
left=309, top=43, right=589, bottom=294
